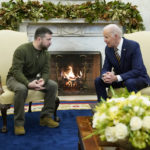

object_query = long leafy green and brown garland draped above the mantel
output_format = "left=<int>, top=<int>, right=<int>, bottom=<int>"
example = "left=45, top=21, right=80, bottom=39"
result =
left=0, top=0, right=144, bottom=33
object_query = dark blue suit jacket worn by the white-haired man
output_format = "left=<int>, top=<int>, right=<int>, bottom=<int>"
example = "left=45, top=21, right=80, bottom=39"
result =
left=101, top=38, right=150, bottom=85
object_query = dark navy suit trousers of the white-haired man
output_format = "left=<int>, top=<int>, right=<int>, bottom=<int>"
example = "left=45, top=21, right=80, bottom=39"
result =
left=95, top=77, right=148, bottom=101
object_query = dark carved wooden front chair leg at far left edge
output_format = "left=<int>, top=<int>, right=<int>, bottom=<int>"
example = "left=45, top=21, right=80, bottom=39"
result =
left=0, top=104, right=10, bottom=133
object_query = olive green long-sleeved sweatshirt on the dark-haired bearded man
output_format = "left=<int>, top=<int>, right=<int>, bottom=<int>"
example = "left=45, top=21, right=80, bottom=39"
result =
left=7, top=43, right=50, bottom=86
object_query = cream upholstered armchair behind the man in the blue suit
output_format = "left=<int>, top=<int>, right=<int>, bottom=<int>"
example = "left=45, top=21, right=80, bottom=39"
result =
left=108, top=31, right=150, bottom=97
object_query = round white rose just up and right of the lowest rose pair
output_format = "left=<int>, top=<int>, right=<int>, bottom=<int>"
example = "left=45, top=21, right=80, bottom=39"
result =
left=130, top=116, right=142, bottom=131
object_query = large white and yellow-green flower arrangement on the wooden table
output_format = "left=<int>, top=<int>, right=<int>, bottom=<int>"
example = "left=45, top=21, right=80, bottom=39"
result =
left=92, top=88, right=150, bottom=149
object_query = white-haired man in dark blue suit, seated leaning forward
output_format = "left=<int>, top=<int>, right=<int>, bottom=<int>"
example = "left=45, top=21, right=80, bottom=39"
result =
left=95, top=24, right=150, bottom=101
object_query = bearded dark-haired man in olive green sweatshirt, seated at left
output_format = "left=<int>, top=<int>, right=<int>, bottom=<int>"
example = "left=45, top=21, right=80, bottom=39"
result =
left=7, top=27, right=59, bottom=135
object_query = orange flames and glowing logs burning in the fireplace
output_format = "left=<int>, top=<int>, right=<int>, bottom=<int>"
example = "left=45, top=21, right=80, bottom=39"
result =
left=61, top=66, right=82, bottom=87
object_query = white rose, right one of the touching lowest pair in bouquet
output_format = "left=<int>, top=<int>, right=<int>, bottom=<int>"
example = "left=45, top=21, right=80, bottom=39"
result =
left=116, top=123, right=128, bottom=140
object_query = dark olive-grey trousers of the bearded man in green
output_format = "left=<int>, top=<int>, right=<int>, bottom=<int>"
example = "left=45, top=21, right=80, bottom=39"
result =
left=7, top=77, right=58, bottom=126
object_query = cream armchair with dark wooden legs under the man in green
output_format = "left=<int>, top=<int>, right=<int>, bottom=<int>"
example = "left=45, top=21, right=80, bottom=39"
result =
left=0, top=30, right=59, bottom=132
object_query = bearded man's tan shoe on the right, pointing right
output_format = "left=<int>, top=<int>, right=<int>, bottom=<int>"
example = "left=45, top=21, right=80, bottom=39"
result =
left=40, top=117, right=59, bottom=128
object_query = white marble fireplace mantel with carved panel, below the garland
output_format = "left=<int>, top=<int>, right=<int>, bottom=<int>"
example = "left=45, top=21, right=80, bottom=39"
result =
left=19, top=19, right=118, bottom=55
